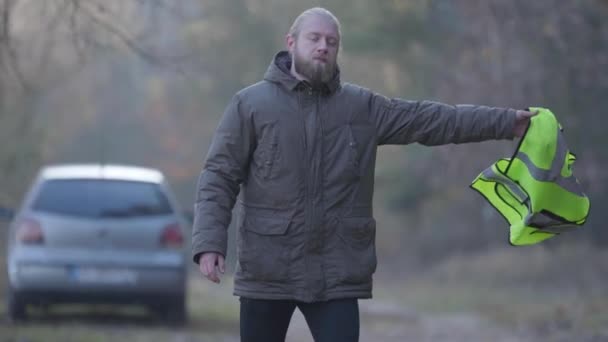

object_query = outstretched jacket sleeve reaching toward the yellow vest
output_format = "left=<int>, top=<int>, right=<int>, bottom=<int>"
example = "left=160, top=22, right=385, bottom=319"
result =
left=370, top=94, right=516, bottom=146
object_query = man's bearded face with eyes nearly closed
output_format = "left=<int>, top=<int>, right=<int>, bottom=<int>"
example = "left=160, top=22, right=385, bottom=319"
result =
left=287, top=15, right=340, bottom=84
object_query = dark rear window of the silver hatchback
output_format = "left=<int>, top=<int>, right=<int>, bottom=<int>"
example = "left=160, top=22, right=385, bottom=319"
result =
left=32, top=179, right=172, bottom=218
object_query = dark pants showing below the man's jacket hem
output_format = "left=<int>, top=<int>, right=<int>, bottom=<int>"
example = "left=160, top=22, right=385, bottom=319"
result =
left=240, top=297, right=359, bottom=342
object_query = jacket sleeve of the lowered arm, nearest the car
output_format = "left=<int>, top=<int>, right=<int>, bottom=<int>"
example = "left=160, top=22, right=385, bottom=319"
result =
left=192, top=94, right=255, bottom=263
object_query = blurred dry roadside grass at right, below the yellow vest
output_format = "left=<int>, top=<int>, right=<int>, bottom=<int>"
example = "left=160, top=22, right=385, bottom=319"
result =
left=375, top=244, right=608, bottom=337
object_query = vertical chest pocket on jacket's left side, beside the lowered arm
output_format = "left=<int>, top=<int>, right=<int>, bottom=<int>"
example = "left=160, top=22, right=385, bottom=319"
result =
left=253, top=121, right=281, bottom=180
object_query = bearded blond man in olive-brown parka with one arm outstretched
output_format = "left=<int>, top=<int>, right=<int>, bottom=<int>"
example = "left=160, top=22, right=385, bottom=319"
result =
left=192, top=8, right=533, bottom=342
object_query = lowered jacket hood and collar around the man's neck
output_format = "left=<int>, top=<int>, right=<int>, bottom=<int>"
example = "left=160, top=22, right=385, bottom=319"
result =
left=264, top=51, right=340, bottom=94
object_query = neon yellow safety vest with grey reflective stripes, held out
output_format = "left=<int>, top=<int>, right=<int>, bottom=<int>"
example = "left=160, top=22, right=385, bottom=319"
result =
left=471, top=108, right=589, bottom=245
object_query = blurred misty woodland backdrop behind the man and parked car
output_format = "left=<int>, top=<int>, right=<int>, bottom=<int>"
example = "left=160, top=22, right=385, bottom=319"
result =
left=0, top=0, right=608, bottom=341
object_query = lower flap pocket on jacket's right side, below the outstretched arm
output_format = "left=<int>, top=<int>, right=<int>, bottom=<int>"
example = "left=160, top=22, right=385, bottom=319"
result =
left=338, top=217, right=377, bottom=284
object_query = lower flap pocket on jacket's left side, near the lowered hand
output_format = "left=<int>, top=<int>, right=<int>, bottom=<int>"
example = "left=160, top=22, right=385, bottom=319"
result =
left=237, top=216, right=291, bottom=282
